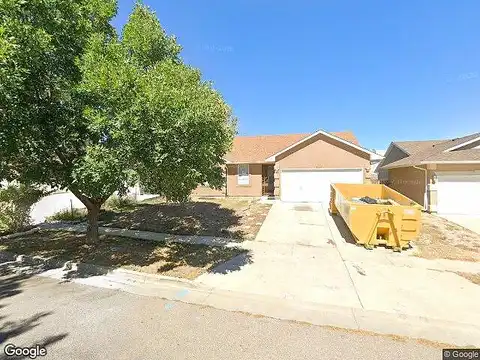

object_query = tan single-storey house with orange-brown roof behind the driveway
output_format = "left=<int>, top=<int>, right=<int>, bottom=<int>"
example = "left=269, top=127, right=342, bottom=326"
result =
left=194, top=130, right=375, bottom=202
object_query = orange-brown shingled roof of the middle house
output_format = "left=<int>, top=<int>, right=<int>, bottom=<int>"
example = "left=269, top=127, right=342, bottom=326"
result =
left=226, top=131, right=358, bottom=163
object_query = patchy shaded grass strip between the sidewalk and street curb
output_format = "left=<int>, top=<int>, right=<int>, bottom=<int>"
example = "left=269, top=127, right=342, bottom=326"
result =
left=0, top=230, right=248, bottom=279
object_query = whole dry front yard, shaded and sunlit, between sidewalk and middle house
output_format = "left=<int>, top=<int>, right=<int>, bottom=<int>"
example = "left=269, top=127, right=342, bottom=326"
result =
left=100, top=198, right=271, bottom=240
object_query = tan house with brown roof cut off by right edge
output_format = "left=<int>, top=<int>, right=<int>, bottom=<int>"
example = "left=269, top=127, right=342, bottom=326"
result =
left=377, top=133, right=480, bottom=214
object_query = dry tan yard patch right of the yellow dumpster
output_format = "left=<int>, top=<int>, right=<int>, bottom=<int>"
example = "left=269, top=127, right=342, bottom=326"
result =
left=413, top=213, right=480, bottom=261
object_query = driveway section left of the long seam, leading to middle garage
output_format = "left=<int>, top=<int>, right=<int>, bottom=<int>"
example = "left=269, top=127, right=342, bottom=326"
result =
left=197, top=202, right=361, bottom=307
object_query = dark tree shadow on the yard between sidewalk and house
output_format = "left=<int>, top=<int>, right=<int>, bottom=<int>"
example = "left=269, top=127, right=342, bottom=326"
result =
left=100, top=201, right=246, bottom=240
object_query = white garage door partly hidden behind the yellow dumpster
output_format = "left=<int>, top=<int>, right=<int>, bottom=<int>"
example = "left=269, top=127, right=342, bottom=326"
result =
left=280, top=169, right=363, bottom=202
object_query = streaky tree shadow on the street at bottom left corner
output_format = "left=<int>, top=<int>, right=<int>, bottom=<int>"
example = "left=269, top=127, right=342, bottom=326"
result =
left=0, top=311, right=68, bottom=360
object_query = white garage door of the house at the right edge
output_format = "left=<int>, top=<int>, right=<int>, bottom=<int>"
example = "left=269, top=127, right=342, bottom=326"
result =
left=437, top=173, right=480, bottom=215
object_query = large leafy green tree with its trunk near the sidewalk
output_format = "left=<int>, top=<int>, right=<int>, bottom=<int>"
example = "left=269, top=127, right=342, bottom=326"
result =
left=0, top=0, right=235, bottom=240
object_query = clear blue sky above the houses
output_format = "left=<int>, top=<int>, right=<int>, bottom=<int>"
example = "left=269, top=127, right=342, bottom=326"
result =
left=114, top=0, right=480, bottom=149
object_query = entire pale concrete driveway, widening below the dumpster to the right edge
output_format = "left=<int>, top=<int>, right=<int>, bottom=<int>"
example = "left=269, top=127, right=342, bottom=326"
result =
left=197, top=202, right=480, bottom=323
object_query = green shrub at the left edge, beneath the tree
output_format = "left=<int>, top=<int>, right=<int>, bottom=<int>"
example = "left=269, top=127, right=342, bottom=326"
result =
left=0, top=184, right=46, bottom=233
